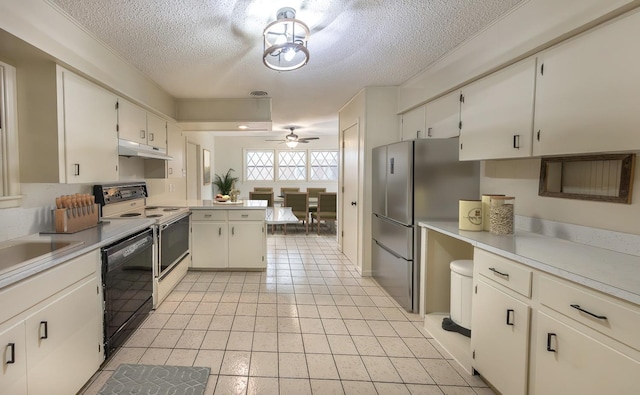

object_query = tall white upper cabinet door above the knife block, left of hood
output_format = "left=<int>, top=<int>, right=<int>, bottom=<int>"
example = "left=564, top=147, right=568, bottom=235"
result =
left=60, top=71, right=118, bottom=183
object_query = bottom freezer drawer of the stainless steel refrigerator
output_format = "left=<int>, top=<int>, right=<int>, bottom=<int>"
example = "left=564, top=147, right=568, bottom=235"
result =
left=371, top=240, right=413, bottom=311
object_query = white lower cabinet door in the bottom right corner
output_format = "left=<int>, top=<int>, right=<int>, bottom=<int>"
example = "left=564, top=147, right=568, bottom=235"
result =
left=531, top=313, right=640, bottom=395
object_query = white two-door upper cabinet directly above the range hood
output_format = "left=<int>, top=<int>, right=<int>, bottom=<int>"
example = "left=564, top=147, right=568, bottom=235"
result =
left=118, top=98, right=167, bottom=149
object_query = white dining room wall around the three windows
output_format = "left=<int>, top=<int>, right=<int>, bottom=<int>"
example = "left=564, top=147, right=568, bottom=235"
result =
left=212, top=133, right=338, bottom=198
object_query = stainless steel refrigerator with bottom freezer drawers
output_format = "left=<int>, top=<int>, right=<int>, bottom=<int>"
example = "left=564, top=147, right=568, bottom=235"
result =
left=371, top=138, right=480, bottom=312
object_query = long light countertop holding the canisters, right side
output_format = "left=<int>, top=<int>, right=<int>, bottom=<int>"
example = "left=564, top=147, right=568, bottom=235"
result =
left=418, top=221, right=640, bottom=305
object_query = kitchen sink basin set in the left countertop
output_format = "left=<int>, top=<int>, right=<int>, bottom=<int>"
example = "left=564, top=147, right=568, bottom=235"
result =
left=0, top=241, right=83, bottom=273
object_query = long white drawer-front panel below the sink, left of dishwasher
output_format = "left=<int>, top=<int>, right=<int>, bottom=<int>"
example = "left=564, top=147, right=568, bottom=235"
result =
left=0, top=250, right=100, bottom=323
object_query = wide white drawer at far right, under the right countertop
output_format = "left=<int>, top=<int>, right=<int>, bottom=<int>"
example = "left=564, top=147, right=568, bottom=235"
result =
left=540, top=276, right=640, bottom=350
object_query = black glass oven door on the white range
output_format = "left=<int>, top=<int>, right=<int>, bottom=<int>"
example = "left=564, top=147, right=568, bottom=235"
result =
left=157, top=212, right=191, bottom=279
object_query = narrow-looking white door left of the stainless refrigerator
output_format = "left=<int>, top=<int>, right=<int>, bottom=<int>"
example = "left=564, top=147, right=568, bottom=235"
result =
left=340, top=123, right=360, bottom=265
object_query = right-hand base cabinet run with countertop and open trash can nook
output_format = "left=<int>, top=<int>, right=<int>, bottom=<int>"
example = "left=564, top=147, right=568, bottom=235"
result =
left=419, top=221, right=640, bottom=394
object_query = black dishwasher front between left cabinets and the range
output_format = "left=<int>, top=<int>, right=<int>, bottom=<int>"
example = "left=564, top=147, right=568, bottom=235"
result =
left=102, top=229, right=155, bottom=358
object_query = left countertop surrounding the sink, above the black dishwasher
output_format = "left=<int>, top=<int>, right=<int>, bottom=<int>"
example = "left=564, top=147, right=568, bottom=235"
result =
left=0, top=219, right=155, bottom=289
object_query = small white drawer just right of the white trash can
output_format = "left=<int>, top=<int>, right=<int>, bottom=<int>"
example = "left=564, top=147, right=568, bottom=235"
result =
left=473, top=248, right=533, bottom=298
